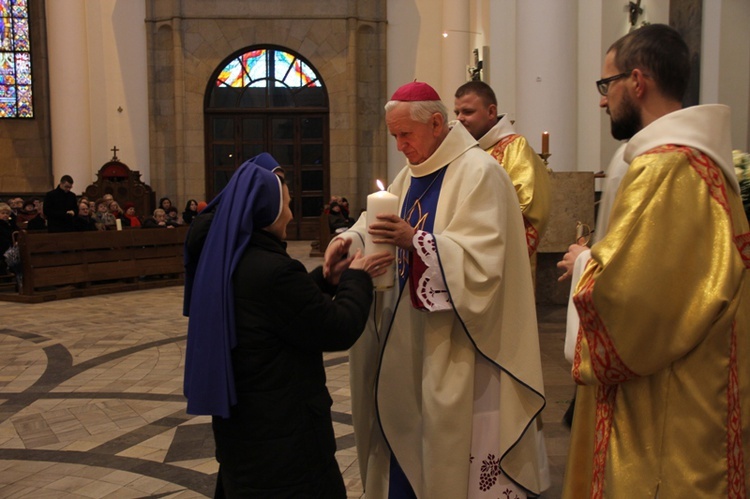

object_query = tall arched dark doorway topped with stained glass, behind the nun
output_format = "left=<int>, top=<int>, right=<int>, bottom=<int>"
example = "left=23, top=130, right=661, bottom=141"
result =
left=205, top=45, right=329, bottom=239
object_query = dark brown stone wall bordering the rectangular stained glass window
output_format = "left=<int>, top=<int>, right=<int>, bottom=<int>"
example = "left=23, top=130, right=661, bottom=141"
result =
left=0, top=0, right=54, bottom=193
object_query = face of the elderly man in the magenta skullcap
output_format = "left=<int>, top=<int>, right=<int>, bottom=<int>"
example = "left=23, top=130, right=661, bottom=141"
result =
left=385, top=102, right=443, bottom=165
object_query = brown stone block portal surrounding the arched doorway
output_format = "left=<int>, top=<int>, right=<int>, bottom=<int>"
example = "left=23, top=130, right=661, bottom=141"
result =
left=146, top=0, right=385, bottom=210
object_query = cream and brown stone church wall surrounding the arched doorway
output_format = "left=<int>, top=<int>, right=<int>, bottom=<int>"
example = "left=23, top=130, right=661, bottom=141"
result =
left=36, top=0, right=750, bottom=209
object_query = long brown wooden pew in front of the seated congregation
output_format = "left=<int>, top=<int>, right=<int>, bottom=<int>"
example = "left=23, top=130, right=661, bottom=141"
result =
left=0, top=227, right=188, bottom=303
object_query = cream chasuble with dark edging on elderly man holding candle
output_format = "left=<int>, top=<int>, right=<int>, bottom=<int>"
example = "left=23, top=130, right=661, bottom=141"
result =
left=339, top=126, right=545, bottom=499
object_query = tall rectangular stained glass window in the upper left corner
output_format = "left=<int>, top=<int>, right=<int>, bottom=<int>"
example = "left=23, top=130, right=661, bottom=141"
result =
left=0, top=0, right=34, bottom=118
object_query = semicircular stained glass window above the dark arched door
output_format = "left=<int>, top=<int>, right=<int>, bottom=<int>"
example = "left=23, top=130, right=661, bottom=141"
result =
left=208, top=46, right=326, bottom=108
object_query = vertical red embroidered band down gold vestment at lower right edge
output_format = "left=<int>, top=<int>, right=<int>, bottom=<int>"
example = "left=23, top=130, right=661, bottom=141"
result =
left=727, top=323, right=747, bottom=499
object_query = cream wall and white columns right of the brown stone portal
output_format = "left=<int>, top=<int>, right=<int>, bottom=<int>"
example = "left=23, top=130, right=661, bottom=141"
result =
left=387, top=0, right=750, bottom=178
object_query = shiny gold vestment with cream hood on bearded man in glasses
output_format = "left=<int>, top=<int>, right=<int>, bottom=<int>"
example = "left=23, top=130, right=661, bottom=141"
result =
left=564, top=106, right=750, bottom=499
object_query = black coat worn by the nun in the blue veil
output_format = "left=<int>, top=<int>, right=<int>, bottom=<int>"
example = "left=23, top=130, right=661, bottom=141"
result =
left=209, top=231, right=372, bottom=499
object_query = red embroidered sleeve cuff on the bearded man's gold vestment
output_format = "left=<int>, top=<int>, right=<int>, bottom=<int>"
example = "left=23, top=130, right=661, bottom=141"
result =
left=573, top=279, right=638, bottom=385
